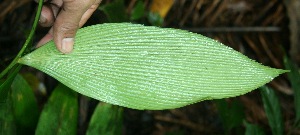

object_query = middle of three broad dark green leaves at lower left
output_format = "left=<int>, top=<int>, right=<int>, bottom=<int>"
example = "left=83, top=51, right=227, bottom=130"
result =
left=35, top=84, right=78, bottom=135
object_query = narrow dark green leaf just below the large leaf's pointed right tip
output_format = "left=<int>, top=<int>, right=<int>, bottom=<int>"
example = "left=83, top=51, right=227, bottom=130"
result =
left=260, top=86, right=284, bottom=135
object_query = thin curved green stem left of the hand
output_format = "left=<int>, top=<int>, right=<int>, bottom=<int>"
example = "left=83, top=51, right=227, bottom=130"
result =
left=0, top=0, right=43, bottom=79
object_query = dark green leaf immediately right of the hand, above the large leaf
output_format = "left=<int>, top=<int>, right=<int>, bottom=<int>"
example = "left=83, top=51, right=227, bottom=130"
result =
left=99, top=0, right=129, bottom=23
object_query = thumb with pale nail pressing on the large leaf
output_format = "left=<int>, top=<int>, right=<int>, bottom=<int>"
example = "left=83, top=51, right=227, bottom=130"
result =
left=53, top=0, right=94, bottom=53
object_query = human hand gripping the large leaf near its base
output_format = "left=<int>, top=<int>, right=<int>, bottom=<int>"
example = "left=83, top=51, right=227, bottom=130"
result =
left=35, top=0, right=101, bottom=54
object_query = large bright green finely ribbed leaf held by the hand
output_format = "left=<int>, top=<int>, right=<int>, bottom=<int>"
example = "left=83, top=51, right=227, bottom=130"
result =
left=19, top=23, right=286, bottom=110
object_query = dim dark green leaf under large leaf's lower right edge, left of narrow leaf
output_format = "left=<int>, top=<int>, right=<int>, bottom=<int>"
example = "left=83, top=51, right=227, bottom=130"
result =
left=215, top=99, right=245, bottom=134
